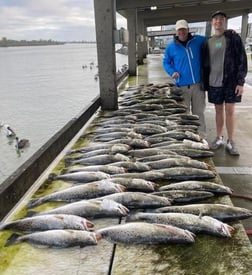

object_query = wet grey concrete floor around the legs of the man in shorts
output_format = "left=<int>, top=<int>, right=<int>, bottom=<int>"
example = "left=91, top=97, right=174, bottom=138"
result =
left=206, top=82, right=252, bottom=244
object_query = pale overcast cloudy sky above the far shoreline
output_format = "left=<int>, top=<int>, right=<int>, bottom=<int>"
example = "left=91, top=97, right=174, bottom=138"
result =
left=0, top=0, right=252, bottom=41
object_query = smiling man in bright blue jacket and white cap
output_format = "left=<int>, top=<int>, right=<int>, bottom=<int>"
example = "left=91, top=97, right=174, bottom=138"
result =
left=163, top=19, right=207, bottom=138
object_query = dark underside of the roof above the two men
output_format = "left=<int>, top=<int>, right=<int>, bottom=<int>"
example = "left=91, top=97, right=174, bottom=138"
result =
left=116, top=0, right=252, bottom=27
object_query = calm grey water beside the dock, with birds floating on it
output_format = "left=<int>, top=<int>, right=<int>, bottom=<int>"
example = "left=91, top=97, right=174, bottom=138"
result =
left=0, top=44, right=128, bottom=183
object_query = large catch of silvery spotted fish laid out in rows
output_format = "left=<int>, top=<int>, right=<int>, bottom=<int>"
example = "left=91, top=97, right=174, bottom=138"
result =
left=0, top=84, right=252, bottom=247
